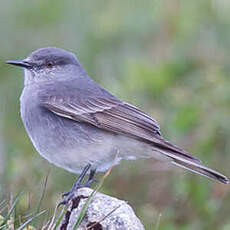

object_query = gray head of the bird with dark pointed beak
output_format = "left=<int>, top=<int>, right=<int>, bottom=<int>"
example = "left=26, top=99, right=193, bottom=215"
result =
left=6, top=47, right=83, bottom=85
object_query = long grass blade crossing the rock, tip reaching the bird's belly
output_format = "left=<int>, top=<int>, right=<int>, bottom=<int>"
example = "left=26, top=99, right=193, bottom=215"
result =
left=73, top=161, right=115, bottom=230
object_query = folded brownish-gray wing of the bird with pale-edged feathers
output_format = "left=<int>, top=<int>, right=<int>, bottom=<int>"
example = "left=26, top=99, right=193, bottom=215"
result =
left=41, top=96, right=200, bottom=162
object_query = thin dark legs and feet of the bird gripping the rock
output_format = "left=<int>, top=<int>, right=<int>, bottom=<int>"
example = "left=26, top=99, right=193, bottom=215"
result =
left=59, top=164, right=91, bottom=205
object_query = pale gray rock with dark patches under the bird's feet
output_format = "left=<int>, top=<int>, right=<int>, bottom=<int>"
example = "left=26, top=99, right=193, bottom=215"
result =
left=59, top=188, right=144, bottom=230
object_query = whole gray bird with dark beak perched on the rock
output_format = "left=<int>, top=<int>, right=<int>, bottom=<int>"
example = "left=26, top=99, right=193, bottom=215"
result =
left=7, top=47, right=229, bottom=202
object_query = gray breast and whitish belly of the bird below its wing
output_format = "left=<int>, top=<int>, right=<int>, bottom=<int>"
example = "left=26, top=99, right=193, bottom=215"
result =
left=22, top=105, right=117, bottom=173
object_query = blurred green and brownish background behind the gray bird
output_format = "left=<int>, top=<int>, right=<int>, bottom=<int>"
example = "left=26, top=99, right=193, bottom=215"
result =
left=0, top=0, right=230, bottom=230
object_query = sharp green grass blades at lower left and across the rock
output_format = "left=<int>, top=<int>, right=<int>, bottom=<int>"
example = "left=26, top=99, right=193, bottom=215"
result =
left=0, top=165, right=116, bottom=230
